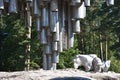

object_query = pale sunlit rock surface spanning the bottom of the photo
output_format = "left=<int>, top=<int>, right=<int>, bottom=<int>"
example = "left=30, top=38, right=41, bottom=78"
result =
left=0, top=69, right=120, bottom=80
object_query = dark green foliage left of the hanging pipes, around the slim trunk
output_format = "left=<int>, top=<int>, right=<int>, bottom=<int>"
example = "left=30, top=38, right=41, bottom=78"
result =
left=0, top=14, right=42, bottom=71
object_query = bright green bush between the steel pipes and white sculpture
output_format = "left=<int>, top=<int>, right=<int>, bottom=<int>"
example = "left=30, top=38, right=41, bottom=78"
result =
left=58, top=48, right=81, bottom=68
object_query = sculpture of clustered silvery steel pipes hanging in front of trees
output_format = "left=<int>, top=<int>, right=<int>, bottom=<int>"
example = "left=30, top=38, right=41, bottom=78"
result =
left=0, top=0, right=114, bottom=70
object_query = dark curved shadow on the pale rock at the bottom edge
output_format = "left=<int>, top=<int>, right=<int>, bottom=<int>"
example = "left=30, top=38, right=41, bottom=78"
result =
left=50, top=77, right=91, bottom=80
